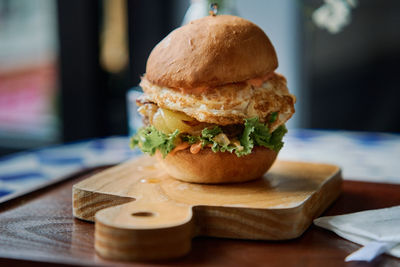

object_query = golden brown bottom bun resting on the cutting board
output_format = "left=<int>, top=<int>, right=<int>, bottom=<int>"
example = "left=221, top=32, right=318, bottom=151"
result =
left=157, top=146, right=277, bottom=184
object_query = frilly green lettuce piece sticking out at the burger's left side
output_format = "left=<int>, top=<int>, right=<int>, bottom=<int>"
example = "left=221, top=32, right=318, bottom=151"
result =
left=131, top=126, right=179, bottom=157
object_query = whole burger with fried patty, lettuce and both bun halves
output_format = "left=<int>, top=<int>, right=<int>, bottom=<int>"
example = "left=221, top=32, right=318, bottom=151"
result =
left=131, top=15, right=295, bottom=184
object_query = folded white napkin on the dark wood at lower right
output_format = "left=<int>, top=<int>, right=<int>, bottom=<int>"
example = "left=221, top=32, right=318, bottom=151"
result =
left=314, top=206, right=400, bottom=261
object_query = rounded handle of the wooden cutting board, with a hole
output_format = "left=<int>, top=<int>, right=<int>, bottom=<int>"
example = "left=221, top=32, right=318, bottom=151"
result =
left=95, top=199, right=194, bottom=260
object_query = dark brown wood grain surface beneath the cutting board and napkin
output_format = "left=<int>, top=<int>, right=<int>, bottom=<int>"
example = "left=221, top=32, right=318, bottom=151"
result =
left=0, top=166, right=400, bottom=267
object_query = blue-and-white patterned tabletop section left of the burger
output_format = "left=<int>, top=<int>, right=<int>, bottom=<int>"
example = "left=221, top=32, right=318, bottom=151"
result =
left=0, top=137, right=140, bottom=203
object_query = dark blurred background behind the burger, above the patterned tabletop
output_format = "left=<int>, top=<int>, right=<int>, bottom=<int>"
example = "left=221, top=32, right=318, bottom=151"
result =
left=0, top=0, right=400, bottom=155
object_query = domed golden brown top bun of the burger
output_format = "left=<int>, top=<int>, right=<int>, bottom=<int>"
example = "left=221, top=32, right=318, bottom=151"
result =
left=145, top=15, right=278, bottom=90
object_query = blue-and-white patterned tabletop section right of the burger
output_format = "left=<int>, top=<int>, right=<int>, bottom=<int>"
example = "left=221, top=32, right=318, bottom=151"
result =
left=279, top=130, right=400, bottom=184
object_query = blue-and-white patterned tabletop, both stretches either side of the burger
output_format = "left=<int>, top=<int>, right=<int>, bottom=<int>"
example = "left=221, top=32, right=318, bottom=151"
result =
left=0, top=129, right=400, bottom=203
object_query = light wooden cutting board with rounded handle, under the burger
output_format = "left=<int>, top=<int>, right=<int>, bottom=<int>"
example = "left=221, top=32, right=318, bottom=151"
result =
left=73, top=156, right=342, bottom=260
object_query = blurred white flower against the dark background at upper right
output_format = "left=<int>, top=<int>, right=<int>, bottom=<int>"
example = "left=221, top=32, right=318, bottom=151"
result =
left=312, top=0, right=357, bottom=33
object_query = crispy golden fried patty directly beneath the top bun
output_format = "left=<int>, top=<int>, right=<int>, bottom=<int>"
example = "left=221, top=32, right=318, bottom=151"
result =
left=140, top=73, right=296, bottom=130
